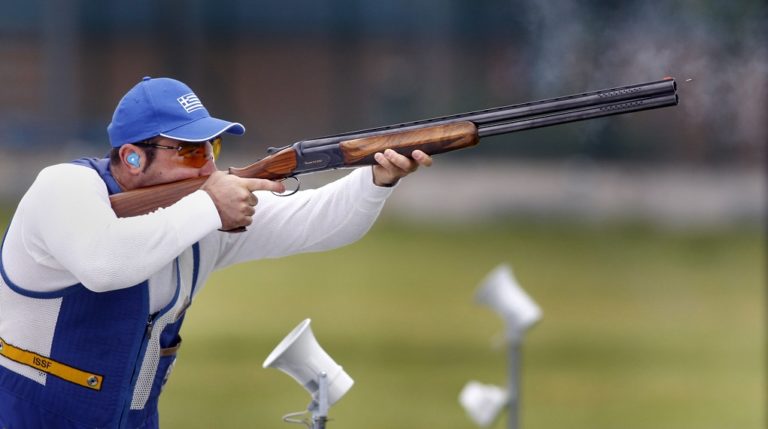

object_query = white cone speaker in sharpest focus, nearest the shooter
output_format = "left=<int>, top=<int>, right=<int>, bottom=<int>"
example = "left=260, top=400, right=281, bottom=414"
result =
left=263, top=319, right=354, bottom=406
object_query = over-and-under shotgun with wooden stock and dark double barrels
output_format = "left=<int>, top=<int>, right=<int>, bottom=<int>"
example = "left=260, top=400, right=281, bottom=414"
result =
left=110, top=77, right=678, bottom=217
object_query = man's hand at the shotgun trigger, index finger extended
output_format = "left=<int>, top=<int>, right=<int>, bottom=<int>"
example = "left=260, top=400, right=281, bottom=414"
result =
left=200, top=171, right=285, bottom=231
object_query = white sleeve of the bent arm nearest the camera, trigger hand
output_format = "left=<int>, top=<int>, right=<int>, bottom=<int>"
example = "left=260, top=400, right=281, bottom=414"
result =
left=9, top=164, right=221, bottom=292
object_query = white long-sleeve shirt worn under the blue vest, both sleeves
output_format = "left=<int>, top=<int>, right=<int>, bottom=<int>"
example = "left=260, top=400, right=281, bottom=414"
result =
left=2, top=164, right=392, bottom=311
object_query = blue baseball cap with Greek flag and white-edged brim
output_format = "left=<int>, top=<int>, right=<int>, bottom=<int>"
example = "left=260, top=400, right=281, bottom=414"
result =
left=107, top=77, right=245, bottom=147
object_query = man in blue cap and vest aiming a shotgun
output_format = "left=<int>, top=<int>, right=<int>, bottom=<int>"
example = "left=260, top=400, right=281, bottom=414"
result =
left=0, top=78, right=432, bottom=428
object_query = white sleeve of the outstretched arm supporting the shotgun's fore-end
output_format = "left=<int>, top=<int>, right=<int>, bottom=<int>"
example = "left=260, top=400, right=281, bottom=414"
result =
left=210, top=168, right=394, bottom=267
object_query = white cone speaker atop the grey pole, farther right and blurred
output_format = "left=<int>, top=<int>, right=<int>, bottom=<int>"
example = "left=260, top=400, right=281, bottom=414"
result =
left=475, top=264, right=541, bottom=338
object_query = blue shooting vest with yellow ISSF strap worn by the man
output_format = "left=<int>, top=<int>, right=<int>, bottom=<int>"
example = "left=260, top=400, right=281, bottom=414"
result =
left=0, top=158, right=200, bottom=429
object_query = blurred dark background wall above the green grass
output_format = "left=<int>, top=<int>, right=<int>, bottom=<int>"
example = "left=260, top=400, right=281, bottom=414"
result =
left=0, top=0, right=768, bottom=223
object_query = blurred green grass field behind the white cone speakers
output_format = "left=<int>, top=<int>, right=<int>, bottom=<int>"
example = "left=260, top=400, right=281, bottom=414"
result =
left=0, top=209, right=766, bottom=429
